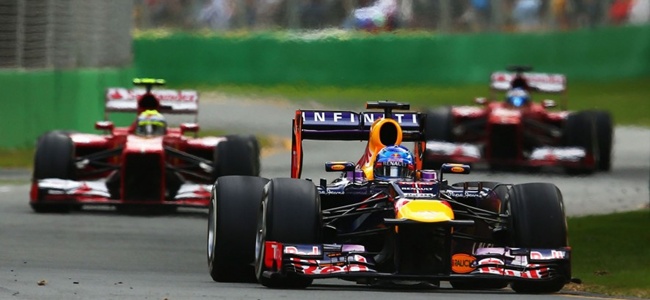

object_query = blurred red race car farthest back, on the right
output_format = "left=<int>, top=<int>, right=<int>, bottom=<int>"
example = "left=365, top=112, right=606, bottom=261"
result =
left=425, top=66, right=613, bottom=174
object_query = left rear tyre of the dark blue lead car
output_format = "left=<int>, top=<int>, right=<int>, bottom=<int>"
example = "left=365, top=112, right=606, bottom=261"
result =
left=207, top=176, right=268, bottom=282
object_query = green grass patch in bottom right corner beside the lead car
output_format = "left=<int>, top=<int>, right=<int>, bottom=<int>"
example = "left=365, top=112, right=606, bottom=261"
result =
left=568, top=209, right=650, bottom=298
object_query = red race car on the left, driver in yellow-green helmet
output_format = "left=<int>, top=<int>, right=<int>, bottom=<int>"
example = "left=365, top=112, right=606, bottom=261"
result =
left=30, top=79, right=260, bottom=212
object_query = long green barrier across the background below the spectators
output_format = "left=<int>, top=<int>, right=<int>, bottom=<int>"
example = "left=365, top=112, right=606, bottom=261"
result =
left=134, top=25, right=650, bottom=86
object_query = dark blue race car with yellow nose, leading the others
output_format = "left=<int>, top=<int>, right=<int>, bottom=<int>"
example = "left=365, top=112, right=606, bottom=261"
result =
left=207, top=101, right=571, bottom=293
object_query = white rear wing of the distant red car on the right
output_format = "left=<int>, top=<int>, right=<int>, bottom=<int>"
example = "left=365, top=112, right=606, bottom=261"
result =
left=490, top=72, right=566, bottom=93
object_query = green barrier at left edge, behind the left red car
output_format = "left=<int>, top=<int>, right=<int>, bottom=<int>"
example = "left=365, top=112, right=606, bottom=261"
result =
left=0, top=67, right=134, bottom=148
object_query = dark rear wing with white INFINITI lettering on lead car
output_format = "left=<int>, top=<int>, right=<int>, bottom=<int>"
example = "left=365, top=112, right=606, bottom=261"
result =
left=291, top=103, right=426, bottom=178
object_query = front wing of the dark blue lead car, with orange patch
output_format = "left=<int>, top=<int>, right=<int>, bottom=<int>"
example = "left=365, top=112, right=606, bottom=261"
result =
left=263, top=241, right=571, bottom=283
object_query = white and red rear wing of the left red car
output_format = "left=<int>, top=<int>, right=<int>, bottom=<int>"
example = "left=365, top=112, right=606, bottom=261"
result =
left=105, top=88, right=199, bottom=114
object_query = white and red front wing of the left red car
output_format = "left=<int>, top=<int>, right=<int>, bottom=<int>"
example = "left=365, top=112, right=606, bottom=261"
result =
left=30, top=178, right=211, bottom=207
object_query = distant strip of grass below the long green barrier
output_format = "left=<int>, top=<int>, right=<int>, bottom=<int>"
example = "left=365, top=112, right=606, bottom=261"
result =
left=194, top=77, right=650, bottom=126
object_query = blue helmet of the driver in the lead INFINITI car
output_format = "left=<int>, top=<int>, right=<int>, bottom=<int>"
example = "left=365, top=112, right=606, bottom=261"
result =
left=374, top=145, right=415, bottom=180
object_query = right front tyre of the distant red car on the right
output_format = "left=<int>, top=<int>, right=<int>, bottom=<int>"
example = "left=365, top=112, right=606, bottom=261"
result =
left=563, top=111, right=598, bottom=175
